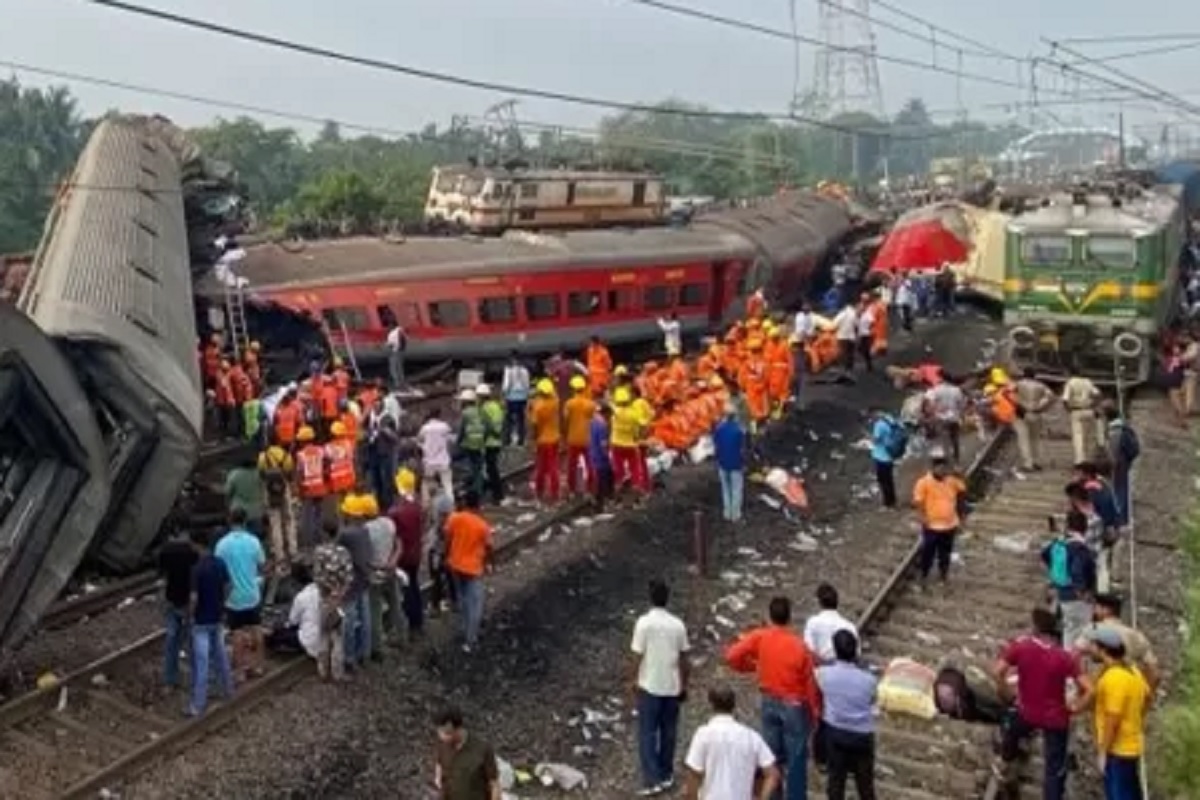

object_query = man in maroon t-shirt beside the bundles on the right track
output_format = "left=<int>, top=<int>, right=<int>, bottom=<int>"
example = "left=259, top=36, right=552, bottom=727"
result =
left=995, top=607, right=1091, bottom=800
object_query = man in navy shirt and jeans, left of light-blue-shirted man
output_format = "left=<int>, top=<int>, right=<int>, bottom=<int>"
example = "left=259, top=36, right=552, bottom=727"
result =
left=187, top=530, right=234, bottom=716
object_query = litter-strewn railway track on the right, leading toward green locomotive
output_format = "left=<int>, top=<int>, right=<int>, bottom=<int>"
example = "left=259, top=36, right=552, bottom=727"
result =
left=814, top=400, right=1132, bottom=800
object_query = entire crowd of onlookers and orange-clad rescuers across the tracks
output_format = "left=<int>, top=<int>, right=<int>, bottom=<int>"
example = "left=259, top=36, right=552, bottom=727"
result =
left=182, top=268, right=1157, bottom=800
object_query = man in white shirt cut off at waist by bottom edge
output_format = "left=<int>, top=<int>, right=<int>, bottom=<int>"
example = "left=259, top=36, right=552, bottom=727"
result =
left=684, top=686, right=780, bottom=800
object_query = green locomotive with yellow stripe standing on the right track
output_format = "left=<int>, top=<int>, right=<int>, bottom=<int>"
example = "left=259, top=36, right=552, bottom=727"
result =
left=1004, top=186, right=1187, bottom=385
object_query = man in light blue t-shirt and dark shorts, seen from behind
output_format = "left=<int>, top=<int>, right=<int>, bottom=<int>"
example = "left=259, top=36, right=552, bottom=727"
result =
left=215, top=509, right=266, bottom=676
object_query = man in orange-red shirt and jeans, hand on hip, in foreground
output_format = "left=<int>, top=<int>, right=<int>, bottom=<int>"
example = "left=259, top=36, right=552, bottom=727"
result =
left=725, top=597, right=821, bottom=800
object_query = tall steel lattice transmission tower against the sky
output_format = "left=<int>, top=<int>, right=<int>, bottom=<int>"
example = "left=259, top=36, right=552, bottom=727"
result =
left=793, top=0, right=883, bottom=119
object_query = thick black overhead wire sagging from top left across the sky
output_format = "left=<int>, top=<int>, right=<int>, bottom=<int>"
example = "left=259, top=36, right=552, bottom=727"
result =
left=72, top=0, right=902, bottom=134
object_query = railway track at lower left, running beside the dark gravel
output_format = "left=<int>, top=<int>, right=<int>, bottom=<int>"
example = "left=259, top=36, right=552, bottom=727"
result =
left=0, top=455, right=590, bottom=800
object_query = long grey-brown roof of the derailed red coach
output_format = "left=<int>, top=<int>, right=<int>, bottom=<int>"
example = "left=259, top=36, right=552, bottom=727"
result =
left=197, top=228, right=754, bottom=295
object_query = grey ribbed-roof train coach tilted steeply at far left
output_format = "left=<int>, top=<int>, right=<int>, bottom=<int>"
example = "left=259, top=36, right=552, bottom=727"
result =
left=18, top=116, right=203, bottom=569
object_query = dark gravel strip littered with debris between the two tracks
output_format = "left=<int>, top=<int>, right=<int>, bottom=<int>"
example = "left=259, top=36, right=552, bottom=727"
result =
left=110, top=314, right=995, bottom=799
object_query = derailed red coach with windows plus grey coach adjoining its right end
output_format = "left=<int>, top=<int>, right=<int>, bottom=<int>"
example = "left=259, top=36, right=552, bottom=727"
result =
left=206, top=192, right=854, bottom=361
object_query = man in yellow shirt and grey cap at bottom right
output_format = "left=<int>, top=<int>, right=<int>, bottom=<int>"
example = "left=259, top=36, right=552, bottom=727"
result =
left=1092, top=626, right=1150, bottom=800
